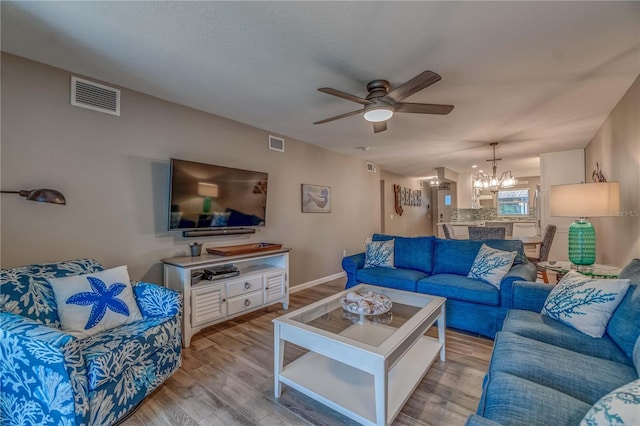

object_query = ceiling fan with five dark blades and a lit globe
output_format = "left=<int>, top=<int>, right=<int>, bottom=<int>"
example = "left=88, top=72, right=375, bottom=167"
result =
left=313, top=71, right=453, bottom=133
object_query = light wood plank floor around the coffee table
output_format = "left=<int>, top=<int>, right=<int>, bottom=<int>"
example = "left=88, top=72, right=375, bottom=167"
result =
left=122, top=279, right=493, bottom=426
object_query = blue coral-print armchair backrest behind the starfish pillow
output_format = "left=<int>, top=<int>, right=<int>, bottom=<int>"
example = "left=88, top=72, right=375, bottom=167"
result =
left=0, top=259, right=102, bottom=328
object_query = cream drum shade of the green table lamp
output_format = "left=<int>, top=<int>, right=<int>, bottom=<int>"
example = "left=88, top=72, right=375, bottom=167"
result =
left=550, top=182, right=620, bottom=218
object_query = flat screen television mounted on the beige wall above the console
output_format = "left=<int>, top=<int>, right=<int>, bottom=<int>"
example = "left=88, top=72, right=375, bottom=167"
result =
left=169, top=158, right=268, bottom=230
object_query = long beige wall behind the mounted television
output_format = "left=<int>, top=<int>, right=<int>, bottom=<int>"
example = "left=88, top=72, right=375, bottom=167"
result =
left=0, top=54, right=380, bottom=285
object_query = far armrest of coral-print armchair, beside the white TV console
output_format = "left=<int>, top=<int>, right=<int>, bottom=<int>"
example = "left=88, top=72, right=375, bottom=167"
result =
left=133, top=281, right=182, bottom=319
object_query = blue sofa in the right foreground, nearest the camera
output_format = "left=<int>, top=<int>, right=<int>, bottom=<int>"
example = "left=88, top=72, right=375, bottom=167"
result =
left=466, top=259, right=640, bottom=426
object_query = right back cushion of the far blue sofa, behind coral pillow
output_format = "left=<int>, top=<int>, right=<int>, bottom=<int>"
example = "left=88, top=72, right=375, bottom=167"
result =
left=433, top=238, right=528, bottom=276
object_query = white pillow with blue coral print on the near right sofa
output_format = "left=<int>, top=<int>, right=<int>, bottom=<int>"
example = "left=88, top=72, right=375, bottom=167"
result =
left=541, top=271, right=629, bottom=337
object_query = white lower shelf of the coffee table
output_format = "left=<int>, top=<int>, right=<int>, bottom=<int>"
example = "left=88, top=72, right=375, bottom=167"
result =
left=279, top=336, right=442, bottom=425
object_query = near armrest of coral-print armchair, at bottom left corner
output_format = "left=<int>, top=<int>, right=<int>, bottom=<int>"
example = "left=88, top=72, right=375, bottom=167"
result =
left=0, top=312, right=89, bottom=424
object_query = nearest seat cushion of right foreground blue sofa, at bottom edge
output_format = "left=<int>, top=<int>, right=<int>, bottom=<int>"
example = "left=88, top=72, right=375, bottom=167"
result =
left=478, top=371, right=590, bottom=426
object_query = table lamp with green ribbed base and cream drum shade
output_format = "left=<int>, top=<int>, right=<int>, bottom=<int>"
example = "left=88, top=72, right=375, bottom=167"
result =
left=550, top=182, right=620, bottom=270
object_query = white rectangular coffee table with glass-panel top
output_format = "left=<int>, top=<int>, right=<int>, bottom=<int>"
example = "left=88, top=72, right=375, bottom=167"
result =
left=273, top=284, right=446, bottom=425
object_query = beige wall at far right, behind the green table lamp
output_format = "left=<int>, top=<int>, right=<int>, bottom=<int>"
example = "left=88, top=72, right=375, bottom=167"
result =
left=585, top=77, right=640, bottom=266
